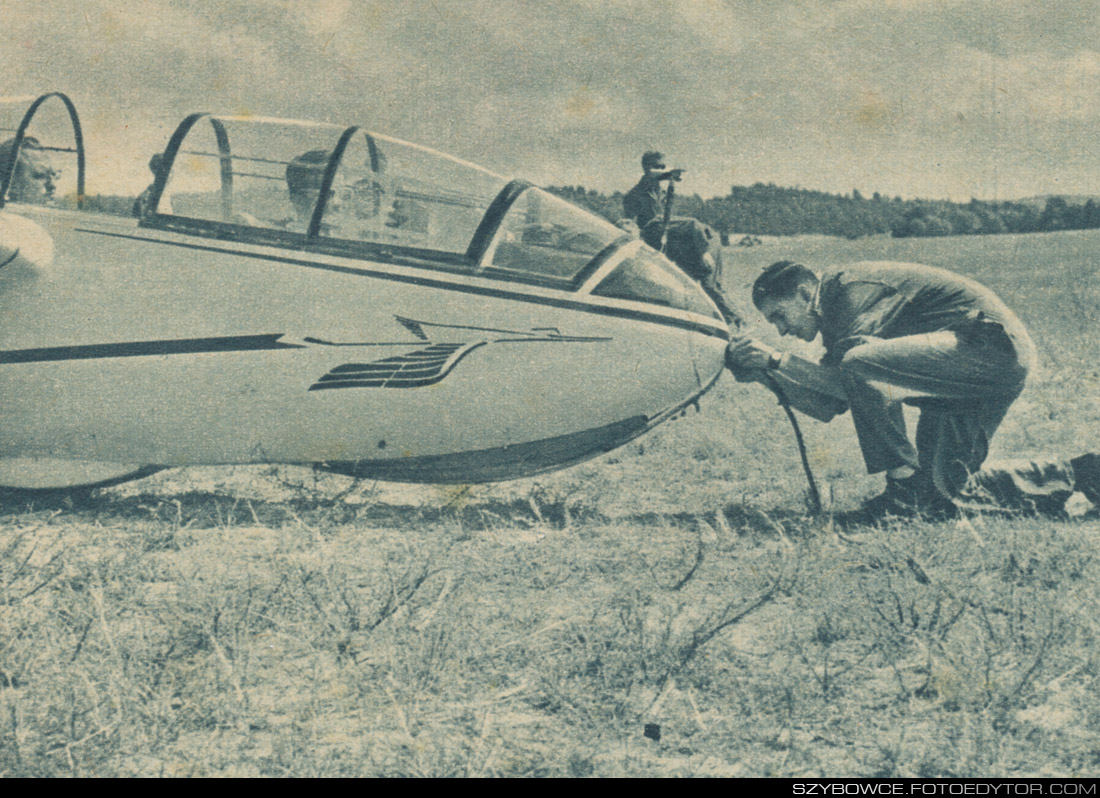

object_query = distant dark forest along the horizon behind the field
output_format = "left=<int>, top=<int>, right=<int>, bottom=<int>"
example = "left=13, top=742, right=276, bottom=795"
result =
left=548, top=183, right=1100, bottom=238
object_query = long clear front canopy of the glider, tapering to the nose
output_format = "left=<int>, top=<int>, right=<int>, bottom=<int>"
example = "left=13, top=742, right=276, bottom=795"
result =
left=141, top=113, right=716, bottom=317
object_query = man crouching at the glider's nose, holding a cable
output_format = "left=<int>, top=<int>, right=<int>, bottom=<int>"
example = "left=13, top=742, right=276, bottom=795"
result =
left=727, top=261, right=1100, bottom=520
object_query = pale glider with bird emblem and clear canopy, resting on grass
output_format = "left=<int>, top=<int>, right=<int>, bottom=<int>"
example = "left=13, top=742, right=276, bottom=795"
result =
left=0, top=92, right=729, bottom=489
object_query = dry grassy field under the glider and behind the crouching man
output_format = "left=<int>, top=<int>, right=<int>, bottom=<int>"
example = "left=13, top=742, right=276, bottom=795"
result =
left=0, top=232, right=1100, bottom=776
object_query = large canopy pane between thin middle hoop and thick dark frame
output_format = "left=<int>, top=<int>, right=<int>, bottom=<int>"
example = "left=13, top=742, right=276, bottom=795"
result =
left=320, top=131, right=505, bottom=254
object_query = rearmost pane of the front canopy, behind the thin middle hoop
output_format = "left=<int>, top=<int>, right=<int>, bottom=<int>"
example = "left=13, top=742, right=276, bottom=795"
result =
left=158, top=117, right=344, bottom=233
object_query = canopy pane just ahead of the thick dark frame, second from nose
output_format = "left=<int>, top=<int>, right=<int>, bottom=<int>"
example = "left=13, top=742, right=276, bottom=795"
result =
left=488, top=188, right=623, bottom=280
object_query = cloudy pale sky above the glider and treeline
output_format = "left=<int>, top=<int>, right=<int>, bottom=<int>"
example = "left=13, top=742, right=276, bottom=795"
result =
left=0, top=0, right=1100, bottom=201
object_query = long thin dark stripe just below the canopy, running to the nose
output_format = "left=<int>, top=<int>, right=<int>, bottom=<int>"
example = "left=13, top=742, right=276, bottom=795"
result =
left=75, top=227, right=729, bottom=340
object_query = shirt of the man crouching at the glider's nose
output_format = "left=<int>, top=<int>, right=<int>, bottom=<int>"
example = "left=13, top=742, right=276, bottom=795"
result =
left=813, top=261, right=1034, bottom=364
